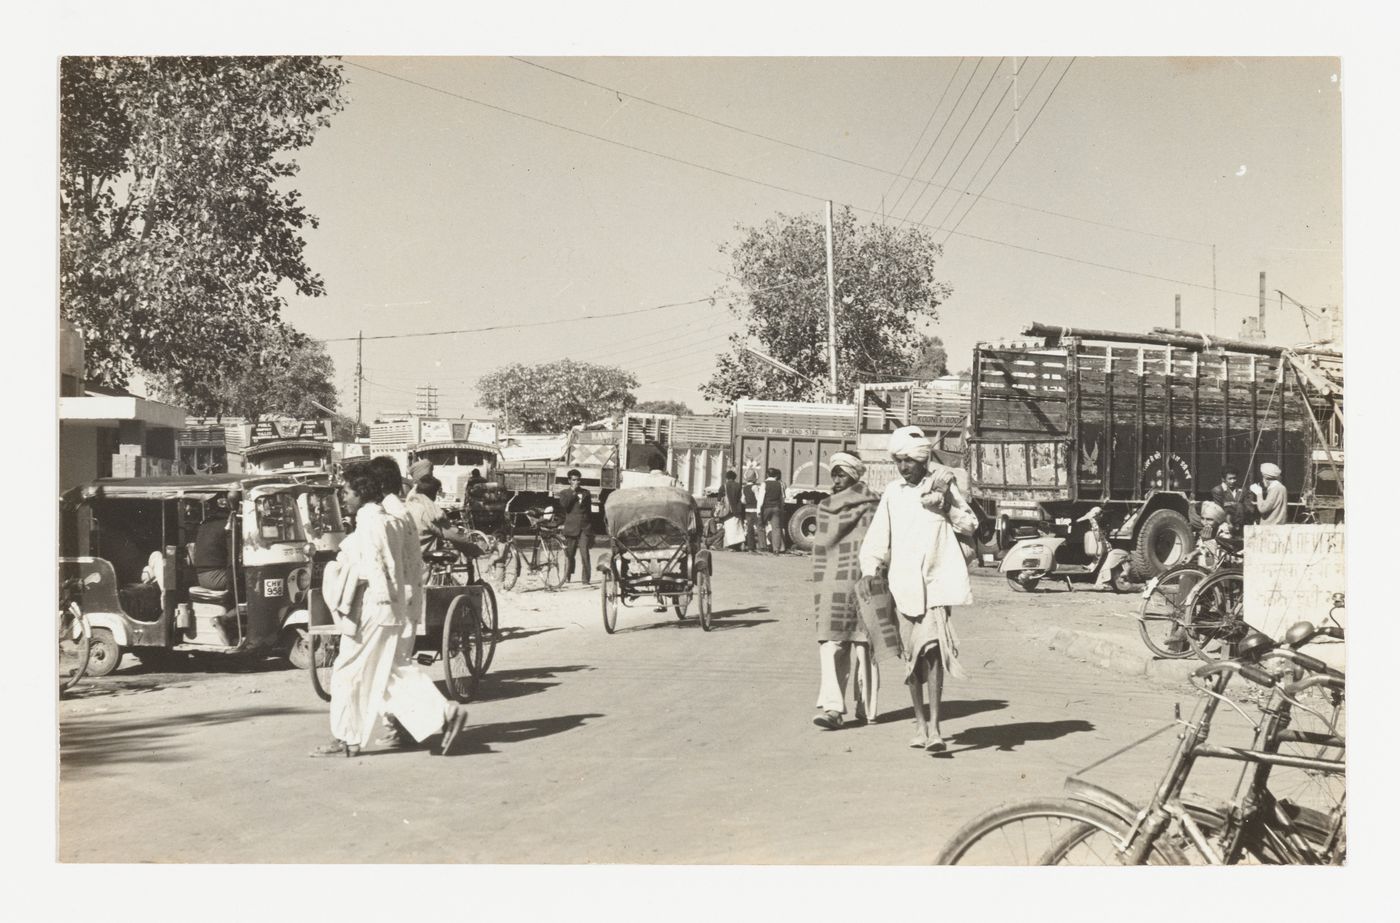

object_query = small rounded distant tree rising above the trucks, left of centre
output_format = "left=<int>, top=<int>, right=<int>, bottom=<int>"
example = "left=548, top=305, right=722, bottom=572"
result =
left=476, top=359, right=637, bottom=433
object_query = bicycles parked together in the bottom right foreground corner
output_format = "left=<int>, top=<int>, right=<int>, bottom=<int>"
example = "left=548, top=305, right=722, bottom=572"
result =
left=935, top=622, right=1345, bottom=866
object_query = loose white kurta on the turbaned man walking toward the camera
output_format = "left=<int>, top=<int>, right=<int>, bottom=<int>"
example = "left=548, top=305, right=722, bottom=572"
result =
left=861, top=479, right=972, bottom=616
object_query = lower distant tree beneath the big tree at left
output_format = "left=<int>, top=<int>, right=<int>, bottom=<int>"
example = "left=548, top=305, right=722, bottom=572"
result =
left=150, top=325, right=338, bottom=414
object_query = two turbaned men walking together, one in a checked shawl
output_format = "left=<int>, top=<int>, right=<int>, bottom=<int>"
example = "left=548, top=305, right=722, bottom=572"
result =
left=812, top=426, right=973, bottom=752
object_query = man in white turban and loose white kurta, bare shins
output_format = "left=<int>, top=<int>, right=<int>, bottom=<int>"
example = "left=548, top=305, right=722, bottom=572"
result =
left=860, top=426, right=972, bottom=751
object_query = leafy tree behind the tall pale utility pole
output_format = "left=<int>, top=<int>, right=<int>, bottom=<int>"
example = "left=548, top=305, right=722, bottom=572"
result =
left=700, top=207, right=952, bottom=405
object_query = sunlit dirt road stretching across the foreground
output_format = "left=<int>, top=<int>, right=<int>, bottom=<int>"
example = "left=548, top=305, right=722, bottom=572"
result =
left=60, top=553, right=1209, bottom=864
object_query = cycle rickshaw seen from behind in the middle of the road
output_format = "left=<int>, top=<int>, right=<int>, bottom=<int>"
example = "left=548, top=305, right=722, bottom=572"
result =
left=598, top=487, right=711, bottom=634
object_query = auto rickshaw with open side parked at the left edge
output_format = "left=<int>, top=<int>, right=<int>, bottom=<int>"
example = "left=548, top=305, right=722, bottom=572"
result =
left=59, top=475, right=344, bottom=676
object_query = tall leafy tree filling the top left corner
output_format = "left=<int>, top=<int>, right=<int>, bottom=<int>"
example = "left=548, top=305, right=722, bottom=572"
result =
left=59, top=57, right=344, bottom=387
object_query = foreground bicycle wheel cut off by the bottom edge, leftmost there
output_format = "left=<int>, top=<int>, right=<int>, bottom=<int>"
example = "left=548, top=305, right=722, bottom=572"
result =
left=934, top=798, right=1186, bottom=866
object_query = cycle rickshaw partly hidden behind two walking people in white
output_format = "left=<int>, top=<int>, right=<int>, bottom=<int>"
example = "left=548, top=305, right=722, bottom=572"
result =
left=311, top=534, right=500, bottom=702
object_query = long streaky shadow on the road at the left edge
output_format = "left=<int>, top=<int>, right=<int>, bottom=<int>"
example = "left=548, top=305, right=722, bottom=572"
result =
left=59, top=707, right=321, bottom=772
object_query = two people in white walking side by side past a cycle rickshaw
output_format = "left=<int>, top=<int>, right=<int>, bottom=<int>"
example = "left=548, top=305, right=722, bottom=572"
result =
left=312, top=457, right=466, bottom=756
